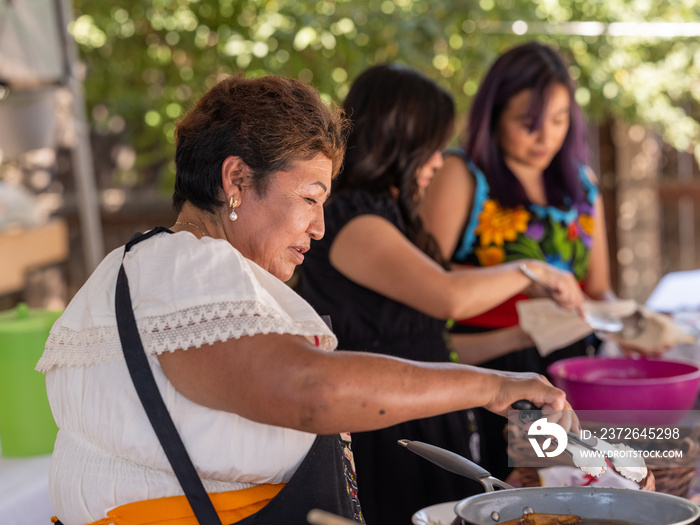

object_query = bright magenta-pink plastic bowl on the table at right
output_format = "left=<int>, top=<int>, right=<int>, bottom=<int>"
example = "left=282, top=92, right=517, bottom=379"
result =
left=547, top=357, right=700, bottom=420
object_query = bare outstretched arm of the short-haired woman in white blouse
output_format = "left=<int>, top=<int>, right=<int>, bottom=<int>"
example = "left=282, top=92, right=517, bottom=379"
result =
left=159, top=334, right=567, bottom=434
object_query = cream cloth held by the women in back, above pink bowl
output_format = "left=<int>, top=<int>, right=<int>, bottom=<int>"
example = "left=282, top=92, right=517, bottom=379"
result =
left=516, top=298, right=695, bottom=356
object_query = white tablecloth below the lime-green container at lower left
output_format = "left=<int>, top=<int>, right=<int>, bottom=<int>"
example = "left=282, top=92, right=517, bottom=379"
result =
left=0, top=455, right=54, bottom=525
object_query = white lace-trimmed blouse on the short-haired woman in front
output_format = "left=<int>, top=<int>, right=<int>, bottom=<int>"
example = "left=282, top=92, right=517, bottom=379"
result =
left=37, top=232, right=337, bottom=525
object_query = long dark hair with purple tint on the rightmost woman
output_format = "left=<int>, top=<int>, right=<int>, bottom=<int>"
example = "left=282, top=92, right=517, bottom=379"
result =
left=464, top=42, right=587, bottom=208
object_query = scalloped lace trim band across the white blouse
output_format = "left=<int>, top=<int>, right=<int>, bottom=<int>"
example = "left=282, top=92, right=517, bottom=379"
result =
left=36, top=300, right=337, bottom=372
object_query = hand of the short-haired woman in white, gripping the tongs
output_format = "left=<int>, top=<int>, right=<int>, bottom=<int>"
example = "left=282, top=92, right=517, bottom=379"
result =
left=484, top=370, right=581, bottom=432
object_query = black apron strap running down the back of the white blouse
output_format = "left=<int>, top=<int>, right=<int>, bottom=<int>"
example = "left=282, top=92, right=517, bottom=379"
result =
left=115, top=226, right=221, bottom=525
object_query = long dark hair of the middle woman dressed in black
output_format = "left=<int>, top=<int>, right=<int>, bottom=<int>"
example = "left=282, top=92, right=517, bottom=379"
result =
left=334, top=64, right=455, bottom=263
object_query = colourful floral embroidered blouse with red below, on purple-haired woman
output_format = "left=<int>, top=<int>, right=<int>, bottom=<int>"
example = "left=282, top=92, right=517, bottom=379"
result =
left=448, top=150, right=598, bottom=327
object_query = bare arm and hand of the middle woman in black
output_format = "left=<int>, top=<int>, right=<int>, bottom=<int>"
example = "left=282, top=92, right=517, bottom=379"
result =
left=329, top=215, right=583, bottom=319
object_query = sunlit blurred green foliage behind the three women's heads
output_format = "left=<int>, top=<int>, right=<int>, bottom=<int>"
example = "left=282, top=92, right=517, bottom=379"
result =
left=71, top=0, right=700, bottom=190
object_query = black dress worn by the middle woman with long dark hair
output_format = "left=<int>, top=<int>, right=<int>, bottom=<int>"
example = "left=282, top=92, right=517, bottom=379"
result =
left=298, top=191, right=483, bottom=525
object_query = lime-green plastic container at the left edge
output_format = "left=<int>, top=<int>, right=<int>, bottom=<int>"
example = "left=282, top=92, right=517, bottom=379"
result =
left=0, top=304, right=62, bottom=457
